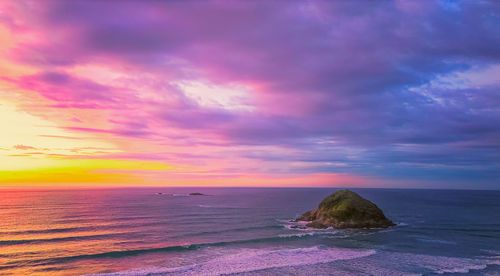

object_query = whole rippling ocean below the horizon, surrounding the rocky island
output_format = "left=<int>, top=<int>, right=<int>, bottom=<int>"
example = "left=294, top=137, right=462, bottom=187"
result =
left=0, top=188, right=500, bottom=275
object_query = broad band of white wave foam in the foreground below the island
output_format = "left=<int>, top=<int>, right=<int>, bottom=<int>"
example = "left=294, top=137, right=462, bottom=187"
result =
left=91, top=246, right=376, bottom=276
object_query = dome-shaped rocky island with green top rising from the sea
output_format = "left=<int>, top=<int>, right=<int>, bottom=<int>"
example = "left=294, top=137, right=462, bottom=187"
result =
left=296, top=190, right=395, bottom=229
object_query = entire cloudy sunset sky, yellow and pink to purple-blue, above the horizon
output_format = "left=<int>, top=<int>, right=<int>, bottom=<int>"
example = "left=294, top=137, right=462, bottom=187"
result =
left=0, top=0, right=500, bottom=189
